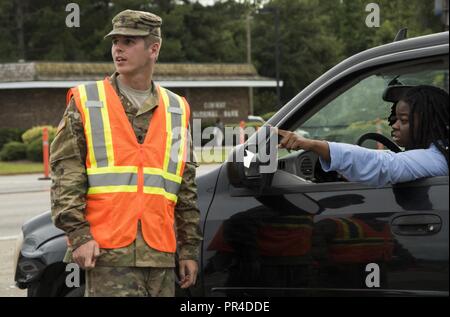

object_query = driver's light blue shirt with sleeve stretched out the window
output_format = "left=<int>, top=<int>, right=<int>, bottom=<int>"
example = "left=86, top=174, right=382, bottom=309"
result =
left=320, top=142, right=448, bottom=187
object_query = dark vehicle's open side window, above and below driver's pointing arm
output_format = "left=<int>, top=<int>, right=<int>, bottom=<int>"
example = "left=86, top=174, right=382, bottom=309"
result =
left=278, top=57, right=449, bottom=183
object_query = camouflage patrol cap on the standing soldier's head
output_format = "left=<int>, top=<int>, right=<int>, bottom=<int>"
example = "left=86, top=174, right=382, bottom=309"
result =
left=105, top=10, right=162, bottom=38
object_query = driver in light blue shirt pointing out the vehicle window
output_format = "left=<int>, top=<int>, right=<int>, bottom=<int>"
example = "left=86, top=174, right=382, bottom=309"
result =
left=278, top=85, right=449, bottom=187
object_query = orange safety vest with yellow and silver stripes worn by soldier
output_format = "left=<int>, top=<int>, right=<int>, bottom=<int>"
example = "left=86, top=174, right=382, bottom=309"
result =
left=67, top=78, right=190, bottom=252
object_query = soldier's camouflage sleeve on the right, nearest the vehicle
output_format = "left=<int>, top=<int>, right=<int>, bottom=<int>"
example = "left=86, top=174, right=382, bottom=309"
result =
left=175, top=126, right=202, bottom=260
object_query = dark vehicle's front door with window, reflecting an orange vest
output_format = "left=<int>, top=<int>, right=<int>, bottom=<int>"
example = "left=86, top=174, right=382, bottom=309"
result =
left=203, top=54, right=449, bottom=296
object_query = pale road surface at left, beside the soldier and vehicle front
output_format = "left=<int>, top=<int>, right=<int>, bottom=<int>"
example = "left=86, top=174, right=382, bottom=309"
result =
left=0, top=164, right=218, bottom=297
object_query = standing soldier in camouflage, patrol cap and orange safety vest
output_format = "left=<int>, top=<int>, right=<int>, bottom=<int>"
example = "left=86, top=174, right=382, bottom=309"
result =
left=50, top=10, right=201, bottom=296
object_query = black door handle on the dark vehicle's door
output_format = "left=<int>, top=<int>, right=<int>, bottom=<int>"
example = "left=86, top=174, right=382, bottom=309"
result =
left=391, top=214, right=442, bottom=236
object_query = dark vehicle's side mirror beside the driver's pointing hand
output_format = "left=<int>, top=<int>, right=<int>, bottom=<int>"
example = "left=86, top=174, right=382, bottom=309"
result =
left=227, top=126, right=279, bottom=191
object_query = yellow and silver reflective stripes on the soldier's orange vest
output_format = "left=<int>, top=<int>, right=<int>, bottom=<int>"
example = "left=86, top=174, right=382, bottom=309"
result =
left=78, top=81, right=187, bottom=202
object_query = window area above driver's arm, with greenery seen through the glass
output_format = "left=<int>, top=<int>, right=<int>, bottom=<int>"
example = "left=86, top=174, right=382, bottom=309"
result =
left=279, top=60, right=449, bottom=158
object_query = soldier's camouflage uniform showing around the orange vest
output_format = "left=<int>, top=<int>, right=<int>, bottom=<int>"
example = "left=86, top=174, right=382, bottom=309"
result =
left=50, top=10, right=202, bottom=296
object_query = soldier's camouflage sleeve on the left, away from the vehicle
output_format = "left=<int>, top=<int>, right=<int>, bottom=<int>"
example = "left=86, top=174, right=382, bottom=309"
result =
left=50, top=99, right=93, bottom=249
